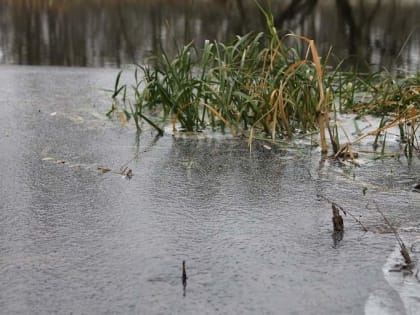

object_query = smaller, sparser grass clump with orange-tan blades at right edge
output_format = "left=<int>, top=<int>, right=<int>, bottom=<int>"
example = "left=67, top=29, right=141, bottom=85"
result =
left=337, top=71, right=420, bottom=157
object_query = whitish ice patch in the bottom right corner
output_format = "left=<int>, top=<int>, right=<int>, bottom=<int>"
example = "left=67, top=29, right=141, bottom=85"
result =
left=365, top=236, right=420, bottom=315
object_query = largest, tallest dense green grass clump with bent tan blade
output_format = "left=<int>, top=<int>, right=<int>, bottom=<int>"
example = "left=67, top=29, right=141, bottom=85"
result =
left=109, top=4, right=328, bottom=149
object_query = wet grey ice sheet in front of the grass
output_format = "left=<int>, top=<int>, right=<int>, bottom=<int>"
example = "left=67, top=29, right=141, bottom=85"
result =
left=0, top=67, right=420, bottom=314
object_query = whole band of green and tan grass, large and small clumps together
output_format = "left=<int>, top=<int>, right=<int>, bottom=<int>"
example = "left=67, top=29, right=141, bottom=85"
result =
left=108, top=3, right=420, bottom=158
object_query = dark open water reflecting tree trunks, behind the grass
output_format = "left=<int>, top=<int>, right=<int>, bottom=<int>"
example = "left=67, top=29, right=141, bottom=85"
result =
left=0, top=0, right=420, bottom=70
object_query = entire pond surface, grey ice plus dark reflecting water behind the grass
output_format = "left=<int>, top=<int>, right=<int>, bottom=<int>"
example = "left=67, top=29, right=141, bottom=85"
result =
left=0, top=0, right=420, bottom=315
